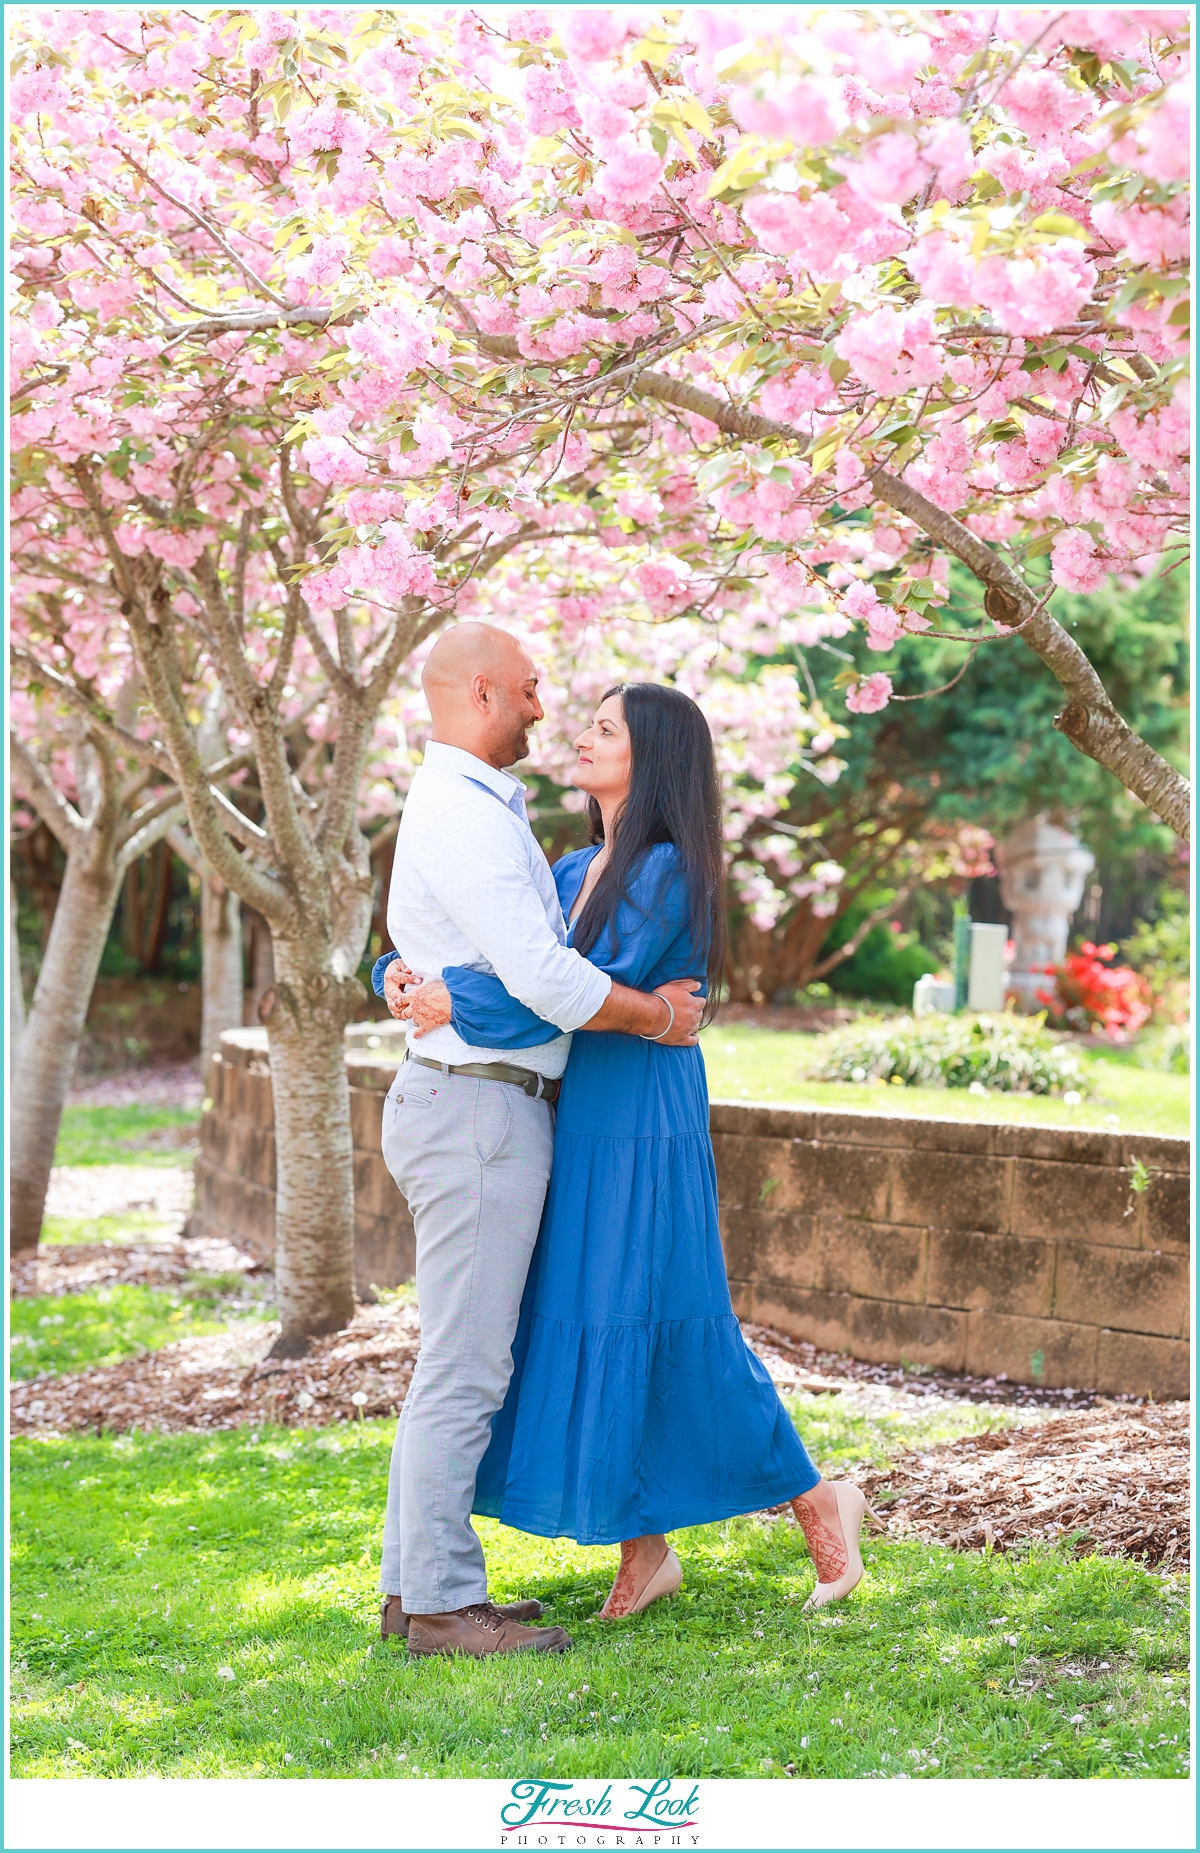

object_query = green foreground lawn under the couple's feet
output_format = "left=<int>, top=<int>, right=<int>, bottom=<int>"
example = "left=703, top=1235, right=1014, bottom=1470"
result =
left=11, top=1421, right=1187, bottom=1779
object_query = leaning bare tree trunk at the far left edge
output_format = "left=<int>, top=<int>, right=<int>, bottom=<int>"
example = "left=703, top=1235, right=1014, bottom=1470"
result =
left=9, top=845, right=120, bottom=1251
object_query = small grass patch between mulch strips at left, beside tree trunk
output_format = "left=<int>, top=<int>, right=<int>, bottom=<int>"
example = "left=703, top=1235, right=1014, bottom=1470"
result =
left=9, top=1275, right=270, bottom=1377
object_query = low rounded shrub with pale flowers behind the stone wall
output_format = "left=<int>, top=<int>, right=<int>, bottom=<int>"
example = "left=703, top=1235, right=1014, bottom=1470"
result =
left=807, top=1012, right=1089, bottom=1095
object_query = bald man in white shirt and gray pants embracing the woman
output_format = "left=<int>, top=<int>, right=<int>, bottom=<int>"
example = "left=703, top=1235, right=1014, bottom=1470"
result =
left=376, top=624, right=704, bottom=1657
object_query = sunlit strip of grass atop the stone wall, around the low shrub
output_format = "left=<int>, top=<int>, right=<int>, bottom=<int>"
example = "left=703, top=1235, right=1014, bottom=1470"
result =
left=700, top=1021, right=1193, bottom=1138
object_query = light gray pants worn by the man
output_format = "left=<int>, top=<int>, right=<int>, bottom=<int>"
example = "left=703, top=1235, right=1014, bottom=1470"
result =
left=380, top=1062, right=554, bottom=1616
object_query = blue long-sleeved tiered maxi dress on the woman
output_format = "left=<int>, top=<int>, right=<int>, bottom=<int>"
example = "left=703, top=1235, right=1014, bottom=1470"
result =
left=444, top=843, right=820, bottom=1544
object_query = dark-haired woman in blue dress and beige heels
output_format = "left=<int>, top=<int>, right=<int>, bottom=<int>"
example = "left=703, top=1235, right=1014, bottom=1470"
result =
left=394, top=684, right=865, bottom=1620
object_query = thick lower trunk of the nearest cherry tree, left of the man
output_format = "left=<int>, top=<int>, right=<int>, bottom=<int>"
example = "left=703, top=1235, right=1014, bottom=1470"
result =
left=259, top=936, right=361, bottom=1356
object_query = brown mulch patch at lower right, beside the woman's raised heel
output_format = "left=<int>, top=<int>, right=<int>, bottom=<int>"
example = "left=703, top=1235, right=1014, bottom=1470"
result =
left=852, top=1403, right=1191, bottom=1569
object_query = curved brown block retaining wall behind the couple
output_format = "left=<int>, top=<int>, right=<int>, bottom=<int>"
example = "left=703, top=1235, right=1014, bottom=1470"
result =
left=196, top=1023, right=1191, bottom=1397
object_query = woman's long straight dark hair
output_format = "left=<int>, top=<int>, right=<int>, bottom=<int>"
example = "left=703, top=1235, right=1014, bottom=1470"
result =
left=574, top=682, right=726, bottom=1021
